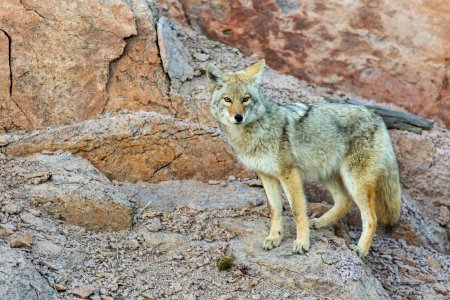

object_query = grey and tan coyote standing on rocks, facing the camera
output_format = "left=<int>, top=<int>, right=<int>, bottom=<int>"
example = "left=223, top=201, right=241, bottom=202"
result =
left=207, top=60, right=401, bottom=257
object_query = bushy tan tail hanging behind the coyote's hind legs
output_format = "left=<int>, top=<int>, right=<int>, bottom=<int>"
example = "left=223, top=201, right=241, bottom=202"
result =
left=376, top=163, right=402, bottom=225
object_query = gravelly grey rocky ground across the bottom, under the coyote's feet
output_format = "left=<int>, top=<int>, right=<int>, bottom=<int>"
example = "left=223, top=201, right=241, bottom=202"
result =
left=0, top=152, right=450, bottom=299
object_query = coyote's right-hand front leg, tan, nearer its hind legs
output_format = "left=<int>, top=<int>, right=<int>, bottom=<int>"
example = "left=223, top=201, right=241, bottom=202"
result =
left=280, top=168, right=309, bottom=253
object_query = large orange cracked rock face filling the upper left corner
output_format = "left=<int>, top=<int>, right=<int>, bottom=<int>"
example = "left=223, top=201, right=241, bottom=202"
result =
left=0, top=0, right=176, bottom=131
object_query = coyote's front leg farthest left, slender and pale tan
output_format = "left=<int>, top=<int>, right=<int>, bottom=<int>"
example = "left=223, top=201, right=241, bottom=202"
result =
left=258, top=174, right=283, bottom=250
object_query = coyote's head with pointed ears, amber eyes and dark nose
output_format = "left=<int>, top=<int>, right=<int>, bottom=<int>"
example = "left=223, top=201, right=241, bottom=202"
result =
left=206, top=59, right=265, bottom=125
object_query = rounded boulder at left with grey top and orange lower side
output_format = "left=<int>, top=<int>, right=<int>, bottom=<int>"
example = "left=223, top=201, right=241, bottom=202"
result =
left=2, top=152, right=132, bottom=231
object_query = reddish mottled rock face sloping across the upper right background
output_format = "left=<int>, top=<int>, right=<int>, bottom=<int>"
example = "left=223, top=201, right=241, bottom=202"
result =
left=158, top=0, right=450, bottom=126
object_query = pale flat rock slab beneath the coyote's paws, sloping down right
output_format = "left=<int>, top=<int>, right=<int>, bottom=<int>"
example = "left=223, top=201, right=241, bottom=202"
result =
left=229, top=221, right=389, bottom=299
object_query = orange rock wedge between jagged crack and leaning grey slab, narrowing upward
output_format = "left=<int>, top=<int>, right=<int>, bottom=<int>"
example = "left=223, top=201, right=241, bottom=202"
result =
left=105, top=0, right=173, bottom=115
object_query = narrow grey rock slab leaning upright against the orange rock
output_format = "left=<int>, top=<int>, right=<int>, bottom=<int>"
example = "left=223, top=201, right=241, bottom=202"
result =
left=157, top=17, right=194, bottom=87
